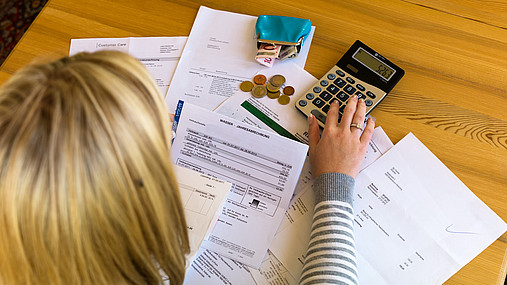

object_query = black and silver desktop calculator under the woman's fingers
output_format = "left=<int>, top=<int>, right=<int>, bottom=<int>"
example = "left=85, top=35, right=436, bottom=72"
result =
left=295, top=41, right=405, bottom=127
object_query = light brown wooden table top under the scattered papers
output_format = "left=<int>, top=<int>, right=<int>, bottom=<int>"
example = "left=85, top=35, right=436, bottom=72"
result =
left=0, top=0, right=507, bottom=284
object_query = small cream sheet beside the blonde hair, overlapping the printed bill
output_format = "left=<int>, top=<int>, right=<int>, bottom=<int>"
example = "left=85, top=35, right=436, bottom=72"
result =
left=174, top=165, right=232, bottom=262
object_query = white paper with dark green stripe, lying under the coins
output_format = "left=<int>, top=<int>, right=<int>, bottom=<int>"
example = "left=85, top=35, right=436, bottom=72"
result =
left=215, top=62, right=317, bottom=143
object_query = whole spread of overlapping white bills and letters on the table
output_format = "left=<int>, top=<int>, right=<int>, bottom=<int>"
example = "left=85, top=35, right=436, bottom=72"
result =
left=71, top=7, right=507, bottom=285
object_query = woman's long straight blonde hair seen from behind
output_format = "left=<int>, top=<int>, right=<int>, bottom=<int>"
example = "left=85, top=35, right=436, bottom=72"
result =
left=0, top=51, right=189, bottom=284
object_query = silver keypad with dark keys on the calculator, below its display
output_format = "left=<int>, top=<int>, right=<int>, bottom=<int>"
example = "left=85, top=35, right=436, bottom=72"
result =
left=296, top=66, right=386, bottom=126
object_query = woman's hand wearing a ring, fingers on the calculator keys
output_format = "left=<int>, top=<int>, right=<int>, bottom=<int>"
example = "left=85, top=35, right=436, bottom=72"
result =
left=308, top=96, right=375, bottom=178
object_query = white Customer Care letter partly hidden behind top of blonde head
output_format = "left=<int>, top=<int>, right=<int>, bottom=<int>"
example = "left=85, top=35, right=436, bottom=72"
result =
left=69, top=37, right=187, bottom=94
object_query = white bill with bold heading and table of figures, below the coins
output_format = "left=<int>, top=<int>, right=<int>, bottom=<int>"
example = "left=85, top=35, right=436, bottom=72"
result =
left=171, top=101, right=308, bottom=268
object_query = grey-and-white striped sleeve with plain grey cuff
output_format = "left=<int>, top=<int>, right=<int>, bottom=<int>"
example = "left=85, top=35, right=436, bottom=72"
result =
left=299, top=173, right=358, bottom=285
